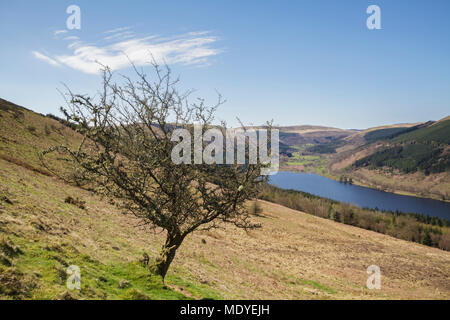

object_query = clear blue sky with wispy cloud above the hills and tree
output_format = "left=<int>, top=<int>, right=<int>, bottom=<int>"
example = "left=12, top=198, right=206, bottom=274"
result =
left=0, top=0, right=450, bottom=129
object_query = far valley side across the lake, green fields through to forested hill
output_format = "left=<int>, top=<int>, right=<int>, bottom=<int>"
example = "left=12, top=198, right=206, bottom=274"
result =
left=281, top=117, right=450, bottom=200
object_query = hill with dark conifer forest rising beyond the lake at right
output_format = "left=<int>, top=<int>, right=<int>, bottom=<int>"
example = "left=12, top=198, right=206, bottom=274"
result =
left=342, top=119, right=450, bottom=200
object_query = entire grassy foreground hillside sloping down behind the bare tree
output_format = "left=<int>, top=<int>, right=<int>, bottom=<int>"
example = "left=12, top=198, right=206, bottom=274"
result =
left=0, top=101, right=450, bottom=299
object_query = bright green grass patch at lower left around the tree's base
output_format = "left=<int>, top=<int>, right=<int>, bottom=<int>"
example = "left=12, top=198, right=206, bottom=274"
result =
left=0, top=236, right=221, bottom=300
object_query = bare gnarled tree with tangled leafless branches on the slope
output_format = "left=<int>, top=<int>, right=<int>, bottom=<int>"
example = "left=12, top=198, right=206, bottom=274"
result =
left=43, top=64, right=272, bottom=279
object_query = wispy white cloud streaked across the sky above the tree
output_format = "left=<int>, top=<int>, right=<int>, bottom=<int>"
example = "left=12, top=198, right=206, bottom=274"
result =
left=33, top=27, right=221, bottom=74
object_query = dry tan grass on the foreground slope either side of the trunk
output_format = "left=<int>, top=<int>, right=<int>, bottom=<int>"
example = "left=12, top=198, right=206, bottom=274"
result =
left=0, top=160, right=450, bottom=299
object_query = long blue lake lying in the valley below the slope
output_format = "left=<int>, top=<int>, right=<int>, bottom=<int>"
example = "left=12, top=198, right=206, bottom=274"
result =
left=269, top=171, right=450, bottom=220
